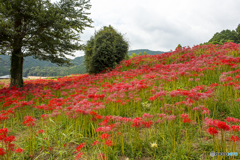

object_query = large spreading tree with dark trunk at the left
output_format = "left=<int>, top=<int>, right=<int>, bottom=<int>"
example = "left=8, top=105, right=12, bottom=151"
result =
left=0, top=0, right=92, bottom=87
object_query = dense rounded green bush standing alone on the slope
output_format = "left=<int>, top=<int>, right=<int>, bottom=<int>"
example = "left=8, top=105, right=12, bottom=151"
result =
left=84, top=25, right=129, bottom=74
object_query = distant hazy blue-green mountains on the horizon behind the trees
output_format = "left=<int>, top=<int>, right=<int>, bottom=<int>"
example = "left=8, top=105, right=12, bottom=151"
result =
left=0, top=49, right=165, bottom=77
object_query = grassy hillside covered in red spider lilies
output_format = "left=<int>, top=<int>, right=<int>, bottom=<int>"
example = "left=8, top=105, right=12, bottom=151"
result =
left=0, top=42, right=240, bottom=160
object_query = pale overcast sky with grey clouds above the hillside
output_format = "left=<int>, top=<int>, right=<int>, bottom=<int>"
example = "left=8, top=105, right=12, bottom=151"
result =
left=67, top=0, right=240, bottom=56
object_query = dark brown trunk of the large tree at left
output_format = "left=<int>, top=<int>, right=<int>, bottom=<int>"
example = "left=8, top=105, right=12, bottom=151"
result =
left=10, top=15, right=23, bottom=88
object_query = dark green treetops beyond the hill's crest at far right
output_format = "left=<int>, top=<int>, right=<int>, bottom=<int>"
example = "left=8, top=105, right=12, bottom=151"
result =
left=208, top=29, right=240, bottom=45
